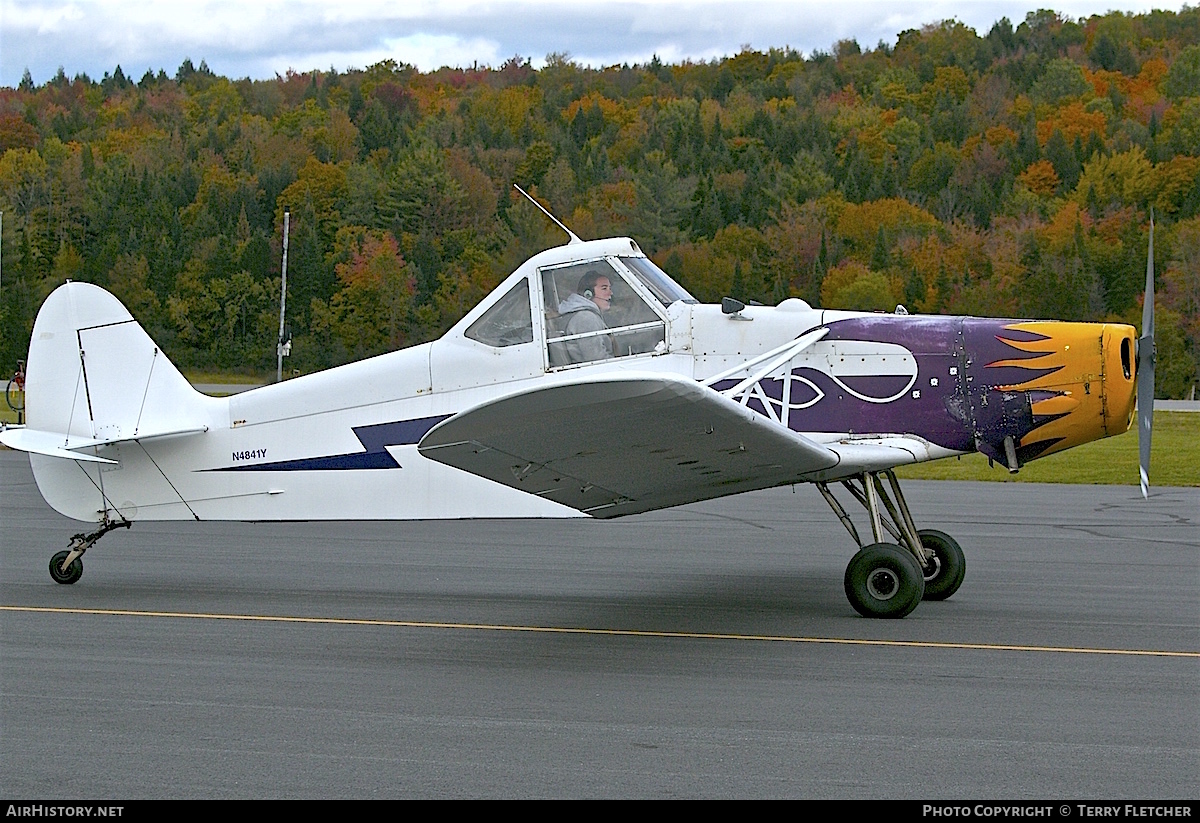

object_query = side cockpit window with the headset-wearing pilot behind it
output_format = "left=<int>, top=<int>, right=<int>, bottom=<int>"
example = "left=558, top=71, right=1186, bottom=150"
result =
left=541, top=258, right=666, bottom=367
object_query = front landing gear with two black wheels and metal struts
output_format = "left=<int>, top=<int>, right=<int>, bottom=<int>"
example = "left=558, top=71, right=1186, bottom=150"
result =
left=817, top=469, right=967, bottom=618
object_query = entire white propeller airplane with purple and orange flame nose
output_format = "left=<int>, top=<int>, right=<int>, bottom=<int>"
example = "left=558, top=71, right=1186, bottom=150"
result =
left=0, top=198, right=1153, bottom=618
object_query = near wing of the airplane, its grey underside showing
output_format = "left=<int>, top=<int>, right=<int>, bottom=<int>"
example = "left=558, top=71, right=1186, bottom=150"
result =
left=418, top=373, right=839, bottom=517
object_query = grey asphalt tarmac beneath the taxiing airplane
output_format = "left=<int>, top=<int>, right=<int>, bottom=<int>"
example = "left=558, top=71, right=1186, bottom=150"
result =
left=0, top=451, right=1200, bottom=801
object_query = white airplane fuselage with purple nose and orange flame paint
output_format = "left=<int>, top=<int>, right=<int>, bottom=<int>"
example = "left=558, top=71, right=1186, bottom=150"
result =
left=29, top=239, right=1134, bottom=521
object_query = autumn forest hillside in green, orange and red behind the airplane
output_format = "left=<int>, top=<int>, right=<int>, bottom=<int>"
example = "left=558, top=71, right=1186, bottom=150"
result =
left=0, top=7, right=1200, bottom=397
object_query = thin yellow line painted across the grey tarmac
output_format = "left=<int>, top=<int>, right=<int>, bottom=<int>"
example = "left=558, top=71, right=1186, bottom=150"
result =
left=0, top=606, right=1200, bottom=659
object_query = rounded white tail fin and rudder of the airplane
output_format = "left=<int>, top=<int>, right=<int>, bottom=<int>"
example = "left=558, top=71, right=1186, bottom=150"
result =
left=7, top=283, right=222, bottom=522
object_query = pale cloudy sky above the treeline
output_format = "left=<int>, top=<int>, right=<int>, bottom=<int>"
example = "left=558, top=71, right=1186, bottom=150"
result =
left=0, top=0, right=1184, bottom=86
